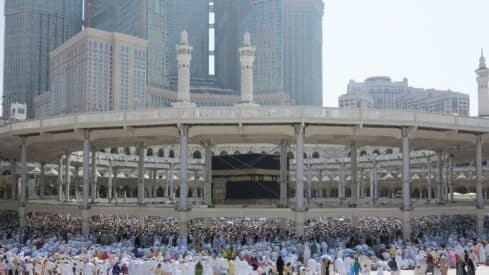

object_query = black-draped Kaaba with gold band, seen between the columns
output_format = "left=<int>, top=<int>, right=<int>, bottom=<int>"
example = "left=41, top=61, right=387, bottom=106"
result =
left=212, top=154, right=286, bottom=200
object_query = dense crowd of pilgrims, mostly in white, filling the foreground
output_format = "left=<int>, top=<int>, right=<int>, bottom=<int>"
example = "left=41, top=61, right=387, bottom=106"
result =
left=0, top=211, right=489, bottom=275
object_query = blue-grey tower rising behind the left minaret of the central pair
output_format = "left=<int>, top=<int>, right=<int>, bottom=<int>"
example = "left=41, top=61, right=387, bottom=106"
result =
left=86, top=0, right=209, bottom=95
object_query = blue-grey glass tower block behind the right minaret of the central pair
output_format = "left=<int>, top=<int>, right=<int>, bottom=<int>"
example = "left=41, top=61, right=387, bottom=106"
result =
left=215, top=0, right=324, bottom=105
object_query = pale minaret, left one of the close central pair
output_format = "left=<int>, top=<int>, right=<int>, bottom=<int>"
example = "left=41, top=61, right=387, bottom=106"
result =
left=173, top=30, right=195, bottom=107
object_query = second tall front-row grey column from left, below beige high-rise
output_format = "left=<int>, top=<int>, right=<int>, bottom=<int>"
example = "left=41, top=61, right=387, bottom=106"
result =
left=81, top=130, right=90, bottom=234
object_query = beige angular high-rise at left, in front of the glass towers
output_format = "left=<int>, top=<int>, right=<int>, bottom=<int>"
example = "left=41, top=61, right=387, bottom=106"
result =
left=35, top=28, right=148, bottom=117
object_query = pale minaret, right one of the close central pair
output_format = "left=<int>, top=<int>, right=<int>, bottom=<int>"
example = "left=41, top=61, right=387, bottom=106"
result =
left=239, top=32, right=256, bottom=106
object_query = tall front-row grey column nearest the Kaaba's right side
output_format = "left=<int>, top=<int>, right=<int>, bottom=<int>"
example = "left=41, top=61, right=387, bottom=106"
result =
left=295, top=125, right=305, bottom=212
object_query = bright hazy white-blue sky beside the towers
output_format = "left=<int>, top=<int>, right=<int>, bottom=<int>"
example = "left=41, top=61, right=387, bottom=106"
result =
left=0, top=0, right=489, bottom=115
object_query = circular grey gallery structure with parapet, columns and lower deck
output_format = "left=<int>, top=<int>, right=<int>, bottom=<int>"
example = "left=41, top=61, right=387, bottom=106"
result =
left=0, top=107, right=489, bottom=240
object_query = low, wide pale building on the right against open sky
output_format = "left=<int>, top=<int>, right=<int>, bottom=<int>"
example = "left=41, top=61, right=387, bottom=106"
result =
left=338, top=76, right=470, bottom=116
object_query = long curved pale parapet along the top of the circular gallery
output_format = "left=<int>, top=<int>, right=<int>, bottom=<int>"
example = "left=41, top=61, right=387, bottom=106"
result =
left=0, top=106, right=489, bottom=135
